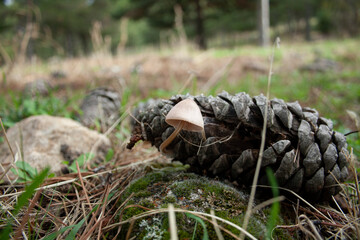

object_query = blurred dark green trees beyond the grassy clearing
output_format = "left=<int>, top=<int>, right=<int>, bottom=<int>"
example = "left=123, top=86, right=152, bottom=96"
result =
left=0, top=0, right=360, bottom=62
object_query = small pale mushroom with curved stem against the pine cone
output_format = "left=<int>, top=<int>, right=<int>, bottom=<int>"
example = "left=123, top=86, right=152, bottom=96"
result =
left=160, top=98, right=205, bottom=154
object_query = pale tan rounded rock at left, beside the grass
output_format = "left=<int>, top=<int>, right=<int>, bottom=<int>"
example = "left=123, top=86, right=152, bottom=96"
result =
left=0, top=115, right=111, bottom=180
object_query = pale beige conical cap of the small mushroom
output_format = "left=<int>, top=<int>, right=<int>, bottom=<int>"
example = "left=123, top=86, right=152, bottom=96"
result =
left=165, top=98, right=204, bottom=132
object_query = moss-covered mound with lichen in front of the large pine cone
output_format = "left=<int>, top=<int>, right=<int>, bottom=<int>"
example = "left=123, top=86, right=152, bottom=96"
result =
left=115, top=166, right=290, bottom=239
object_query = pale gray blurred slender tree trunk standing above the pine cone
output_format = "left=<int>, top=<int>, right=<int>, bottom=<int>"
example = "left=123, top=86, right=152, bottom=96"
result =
left=257, top=0, right=270, bottom=47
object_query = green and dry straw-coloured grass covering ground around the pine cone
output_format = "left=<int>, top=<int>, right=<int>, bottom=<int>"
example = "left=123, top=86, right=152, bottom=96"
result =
left=0, top=36, right=360, bottom=239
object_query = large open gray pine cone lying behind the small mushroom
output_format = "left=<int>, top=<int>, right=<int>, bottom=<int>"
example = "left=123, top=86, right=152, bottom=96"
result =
left=128, top=92, right=349, bottom=201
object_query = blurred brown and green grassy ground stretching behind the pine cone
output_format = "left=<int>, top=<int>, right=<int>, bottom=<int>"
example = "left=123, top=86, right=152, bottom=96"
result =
left=0, top=36, right=360, bottom=239
